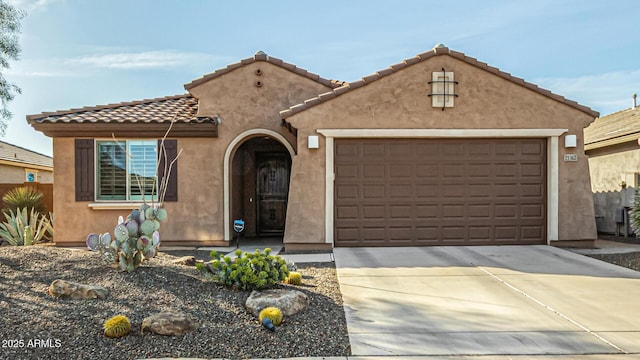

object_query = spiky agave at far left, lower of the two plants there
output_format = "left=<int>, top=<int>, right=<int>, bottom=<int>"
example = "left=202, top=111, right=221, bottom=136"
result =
left=0, top=208, right=53, bottom=246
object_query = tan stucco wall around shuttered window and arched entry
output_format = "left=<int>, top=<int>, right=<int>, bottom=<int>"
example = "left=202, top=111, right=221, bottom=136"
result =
left=53, top=61, right=329, bottom=245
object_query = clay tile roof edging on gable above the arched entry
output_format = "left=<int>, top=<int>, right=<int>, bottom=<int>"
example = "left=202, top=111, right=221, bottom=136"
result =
left=184, top=51, right=345, bottom=91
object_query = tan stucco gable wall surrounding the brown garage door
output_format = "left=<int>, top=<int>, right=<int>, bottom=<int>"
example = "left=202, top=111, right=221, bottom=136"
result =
left=285, top=56, right=596, bottom=243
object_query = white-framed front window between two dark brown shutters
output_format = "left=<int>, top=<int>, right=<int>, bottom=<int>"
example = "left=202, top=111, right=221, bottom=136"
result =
left=96, top=140, right=158, bottom=201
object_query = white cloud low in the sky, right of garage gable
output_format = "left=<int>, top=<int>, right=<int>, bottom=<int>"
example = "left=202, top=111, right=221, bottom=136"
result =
left=533, top=69, right=640, bottom=116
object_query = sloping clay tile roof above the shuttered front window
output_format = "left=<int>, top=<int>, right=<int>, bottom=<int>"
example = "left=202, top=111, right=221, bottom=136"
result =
left=27, top=94, right=198, bottom=124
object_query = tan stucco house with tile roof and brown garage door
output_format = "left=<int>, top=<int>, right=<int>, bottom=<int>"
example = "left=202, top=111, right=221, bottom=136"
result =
left=27, top=46, right=598, bottom=250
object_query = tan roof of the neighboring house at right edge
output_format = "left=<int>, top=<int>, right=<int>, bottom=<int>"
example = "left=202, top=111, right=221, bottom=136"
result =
left=584, top=106, right=640, bottom=150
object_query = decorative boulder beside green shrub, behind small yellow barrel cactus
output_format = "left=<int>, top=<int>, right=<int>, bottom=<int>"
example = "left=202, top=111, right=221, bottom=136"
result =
left=245, top=289, right=309, bottom=316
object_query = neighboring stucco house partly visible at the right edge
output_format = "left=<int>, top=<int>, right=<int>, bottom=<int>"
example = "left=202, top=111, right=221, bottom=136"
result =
left=584, top=102, right=640, bottom=235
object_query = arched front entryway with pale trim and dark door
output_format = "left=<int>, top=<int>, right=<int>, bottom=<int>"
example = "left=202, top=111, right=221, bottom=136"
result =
left=225, top=130, right=294, bottom=240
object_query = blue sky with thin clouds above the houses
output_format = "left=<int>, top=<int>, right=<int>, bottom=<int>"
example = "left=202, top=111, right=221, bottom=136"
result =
left=2, top=0, right=640, bottom=155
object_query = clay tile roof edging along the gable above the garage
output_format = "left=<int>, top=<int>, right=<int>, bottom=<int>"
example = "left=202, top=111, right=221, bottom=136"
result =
left=280, top=46, right=599, bottom=119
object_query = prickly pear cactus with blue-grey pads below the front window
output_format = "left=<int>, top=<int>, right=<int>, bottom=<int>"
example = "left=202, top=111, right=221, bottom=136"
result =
left=87, top=204, right=167, bottom=272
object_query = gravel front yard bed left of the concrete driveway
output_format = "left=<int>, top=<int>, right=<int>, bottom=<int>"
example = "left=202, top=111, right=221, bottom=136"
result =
left=0, top=246, right=350, bottom=359
